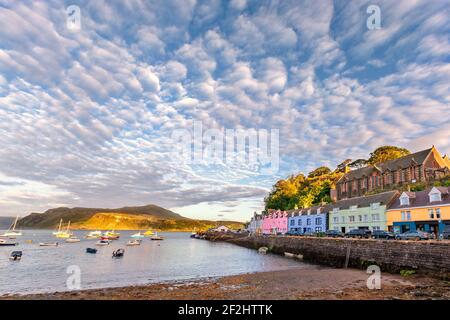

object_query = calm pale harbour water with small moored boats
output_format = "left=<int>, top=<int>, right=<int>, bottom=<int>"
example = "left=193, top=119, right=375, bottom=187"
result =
left=0, top=230, right=304, bottom=295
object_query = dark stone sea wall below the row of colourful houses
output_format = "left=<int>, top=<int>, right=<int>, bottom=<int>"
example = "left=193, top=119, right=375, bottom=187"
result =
left=207, top=233, right=450, bottom=279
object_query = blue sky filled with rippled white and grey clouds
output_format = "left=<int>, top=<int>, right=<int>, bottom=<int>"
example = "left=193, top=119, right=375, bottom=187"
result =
left=0, top=0, right=450, bottom=221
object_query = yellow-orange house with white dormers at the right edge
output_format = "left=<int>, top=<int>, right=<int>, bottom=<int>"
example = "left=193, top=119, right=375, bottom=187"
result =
left=387, top=187, right=450, bottom=236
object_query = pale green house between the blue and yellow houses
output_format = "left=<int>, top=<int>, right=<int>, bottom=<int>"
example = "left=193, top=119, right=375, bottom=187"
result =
left=329, top=191, right=398, bottom=233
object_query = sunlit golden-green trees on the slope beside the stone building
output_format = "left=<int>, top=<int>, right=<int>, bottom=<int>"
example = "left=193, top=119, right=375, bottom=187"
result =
left=264, top=146, right=410, bottom=210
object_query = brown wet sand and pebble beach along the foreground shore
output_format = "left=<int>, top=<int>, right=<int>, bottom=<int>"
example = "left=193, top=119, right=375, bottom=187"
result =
left=0, top=265, right=450, bottom=300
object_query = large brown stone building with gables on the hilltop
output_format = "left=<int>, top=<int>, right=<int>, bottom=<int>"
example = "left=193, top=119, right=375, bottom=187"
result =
left=331, top=146, right=450, bottom=200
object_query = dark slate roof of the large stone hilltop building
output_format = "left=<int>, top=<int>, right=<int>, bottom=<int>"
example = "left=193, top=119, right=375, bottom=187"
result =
left=339, top=148, right=433, bottom=181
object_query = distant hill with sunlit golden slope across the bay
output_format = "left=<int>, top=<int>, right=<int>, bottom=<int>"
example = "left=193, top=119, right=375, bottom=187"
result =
left=18, top=204, right=243, bottom=231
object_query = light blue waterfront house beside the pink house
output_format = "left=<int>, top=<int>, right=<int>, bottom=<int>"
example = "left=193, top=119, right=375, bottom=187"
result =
left=288, top=205, right=332, bottom=233
